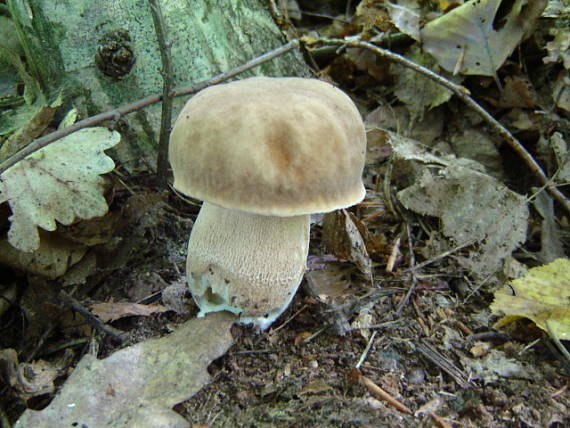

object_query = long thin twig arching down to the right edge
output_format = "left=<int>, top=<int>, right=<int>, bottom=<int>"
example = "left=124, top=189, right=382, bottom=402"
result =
left=301, top=37, right=570, bottom=217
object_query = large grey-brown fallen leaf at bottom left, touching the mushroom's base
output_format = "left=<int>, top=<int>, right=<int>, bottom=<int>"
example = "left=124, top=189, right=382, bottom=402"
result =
left=14, top=312, right=235, bottom=428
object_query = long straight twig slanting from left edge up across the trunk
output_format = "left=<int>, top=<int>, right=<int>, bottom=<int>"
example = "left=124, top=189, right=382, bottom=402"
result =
left=0, top=39, right=299, bottom=174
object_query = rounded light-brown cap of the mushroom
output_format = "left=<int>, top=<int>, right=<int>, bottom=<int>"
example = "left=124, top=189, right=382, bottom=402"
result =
left=169, top=77, right=366, bottom=216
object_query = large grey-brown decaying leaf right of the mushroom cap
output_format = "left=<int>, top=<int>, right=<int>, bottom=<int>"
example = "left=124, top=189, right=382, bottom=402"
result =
left=390, top=137, right=529, bottom=276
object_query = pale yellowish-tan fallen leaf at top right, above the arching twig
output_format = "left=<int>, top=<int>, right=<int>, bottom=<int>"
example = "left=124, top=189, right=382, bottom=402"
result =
left=421, top=0, right=547, bottom=76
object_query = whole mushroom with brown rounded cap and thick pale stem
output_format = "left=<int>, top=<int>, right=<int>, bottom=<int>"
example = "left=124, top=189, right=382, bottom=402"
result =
left=169, top=77, right=366, bottom=329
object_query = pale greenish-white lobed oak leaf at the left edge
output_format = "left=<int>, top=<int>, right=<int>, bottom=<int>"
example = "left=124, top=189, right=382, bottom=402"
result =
left=0, top=128, right=120, bottom=252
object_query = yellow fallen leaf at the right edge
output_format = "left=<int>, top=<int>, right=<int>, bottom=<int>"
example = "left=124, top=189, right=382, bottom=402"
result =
left=491, top=259, right=570, bottom=340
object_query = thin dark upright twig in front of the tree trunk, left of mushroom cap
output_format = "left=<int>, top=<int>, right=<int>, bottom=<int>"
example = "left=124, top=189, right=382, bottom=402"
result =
left=148, top=0, right=174, bottom=188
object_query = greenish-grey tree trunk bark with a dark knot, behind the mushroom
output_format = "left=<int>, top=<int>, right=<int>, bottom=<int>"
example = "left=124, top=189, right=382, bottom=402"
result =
left=8, top=0, right=308, bottom=170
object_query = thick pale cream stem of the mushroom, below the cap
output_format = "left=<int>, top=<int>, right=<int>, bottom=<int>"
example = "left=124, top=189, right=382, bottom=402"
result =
left=186, top=202, right=310, bottom=329
